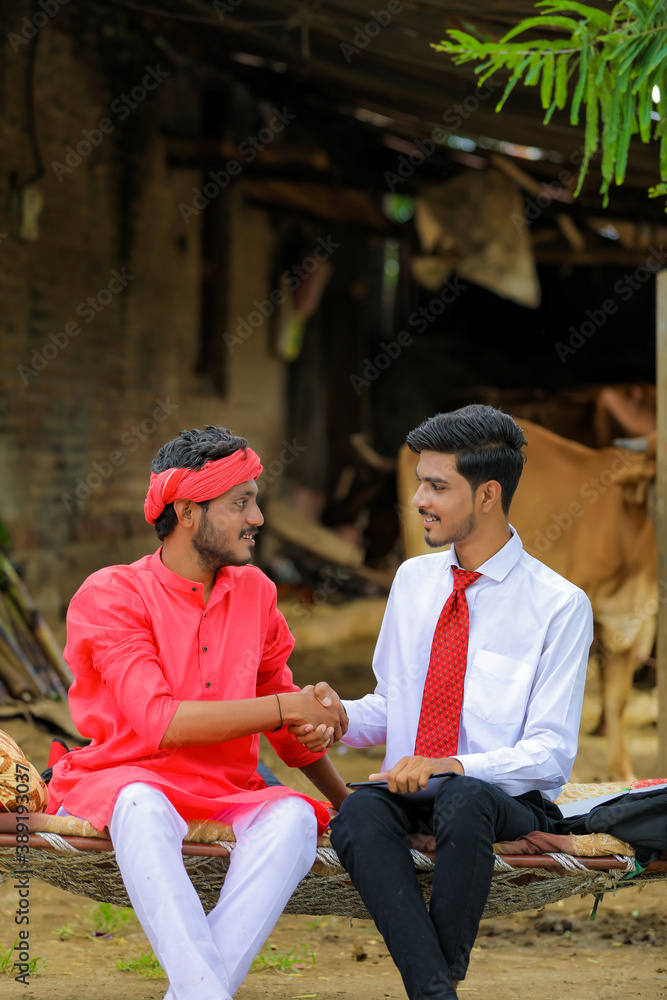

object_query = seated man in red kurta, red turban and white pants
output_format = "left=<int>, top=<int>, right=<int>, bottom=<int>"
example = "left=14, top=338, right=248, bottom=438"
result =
left=49, top=427, right=346, bottom=1000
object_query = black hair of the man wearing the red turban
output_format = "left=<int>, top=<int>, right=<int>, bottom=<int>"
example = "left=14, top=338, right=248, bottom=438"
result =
left=151, top=424, right=248, bottom=541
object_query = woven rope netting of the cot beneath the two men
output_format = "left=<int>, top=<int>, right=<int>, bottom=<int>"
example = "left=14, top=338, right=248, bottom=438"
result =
left=0, top=832, right=667, bottom=918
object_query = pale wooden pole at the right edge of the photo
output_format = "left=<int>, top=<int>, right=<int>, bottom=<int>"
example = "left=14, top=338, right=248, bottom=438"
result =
left=656, top=270, right=667, bottom=777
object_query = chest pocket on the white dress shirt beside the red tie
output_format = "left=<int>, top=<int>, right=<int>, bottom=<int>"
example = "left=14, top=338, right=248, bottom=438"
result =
left=463, top=649, right=533, bottom=726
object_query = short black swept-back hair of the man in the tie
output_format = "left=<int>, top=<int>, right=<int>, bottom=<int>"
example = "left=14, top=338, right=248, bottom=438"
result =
left=406, top=403, right=528, bottom=515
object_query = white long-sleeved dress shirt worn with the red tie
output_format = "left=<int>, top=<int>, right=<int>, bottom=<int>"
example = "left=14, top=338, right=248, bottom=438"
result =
left=343, top=528, right=593, bottom=799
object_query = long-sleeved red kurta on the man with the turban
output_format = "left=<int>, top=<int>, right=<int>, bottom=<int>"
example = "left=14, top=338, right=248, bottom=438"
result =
left=49, top=550, right=329, bottom=832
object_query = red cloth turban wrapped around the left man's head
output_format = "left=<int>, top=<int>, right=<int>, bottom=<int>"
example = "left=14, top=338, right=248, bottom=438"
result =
left=144, top=448, right=262, bottom=524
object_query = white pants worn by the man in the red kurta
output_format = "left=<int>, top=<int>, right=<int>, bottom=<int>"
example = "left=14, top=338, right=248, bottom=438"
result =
left=109, top=783, right=317, bottom=1000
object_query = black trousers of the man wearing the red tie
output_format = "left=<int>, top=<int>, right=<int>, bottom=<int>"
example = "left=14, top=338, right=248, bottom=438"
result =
left=331, top=774, right=560, bottom=1000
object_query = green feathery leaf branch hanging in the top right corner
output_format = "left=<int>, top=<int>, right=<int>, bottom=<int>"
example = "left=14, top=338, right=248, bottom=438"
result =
left=434, top=0, right=667, bottom=204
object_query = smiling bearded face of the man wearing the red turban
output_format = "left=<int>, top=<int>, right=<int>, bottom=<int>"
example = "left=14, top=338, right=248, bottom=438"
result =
left=192, top=479, right=264, bottom=571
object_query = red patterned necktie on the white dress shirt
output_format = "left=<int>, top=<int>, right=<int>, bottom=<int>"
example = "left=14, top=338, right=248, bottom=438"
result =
left=415, top=566, right=482, bottom=757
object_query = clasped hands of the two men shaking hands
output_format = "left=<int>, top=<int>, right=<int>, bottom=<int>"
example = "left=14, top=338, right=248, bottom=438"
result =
left=280, top=681, right=348, bottom=753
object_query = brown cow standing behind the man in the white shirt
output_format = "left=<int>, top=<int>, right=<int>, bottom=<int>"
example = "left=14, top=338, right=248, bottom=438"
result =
left=398, top=420, right=658, bottom=780
